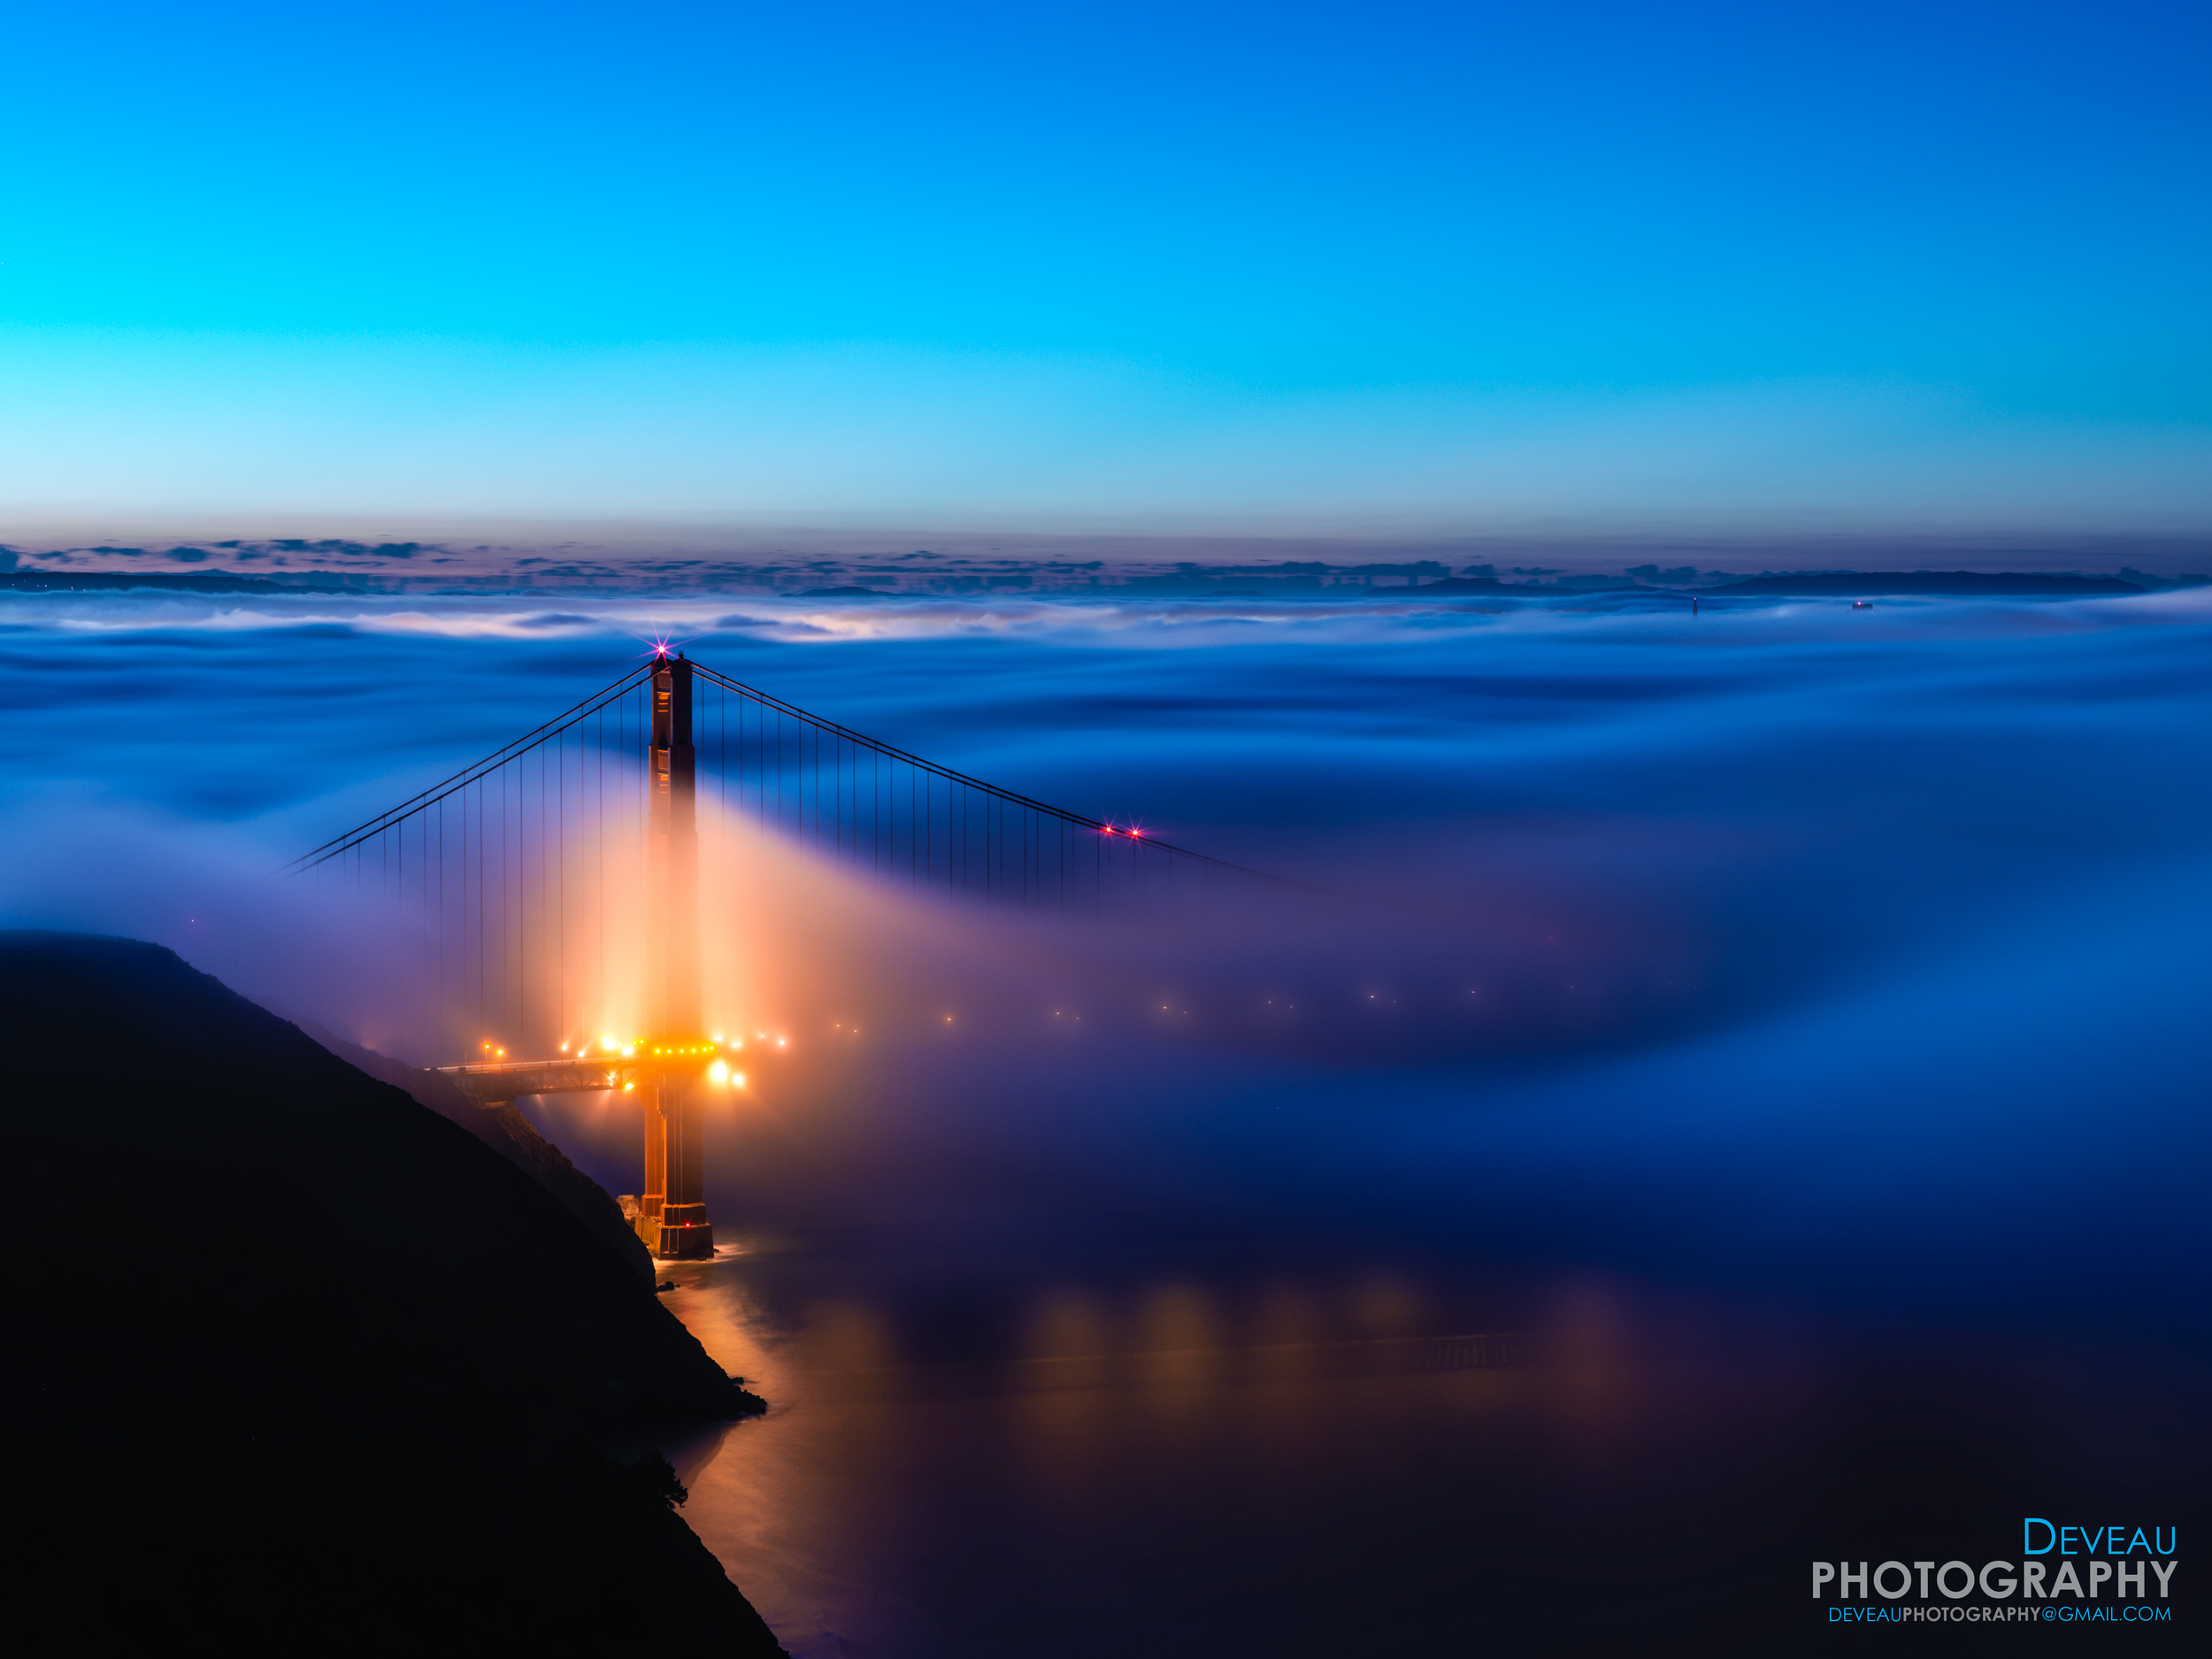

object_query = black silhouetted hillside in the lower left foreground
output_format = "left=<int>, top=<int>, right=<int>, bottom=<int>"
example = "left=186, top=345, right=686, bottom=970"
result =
left=0, top=933, right=781, bottom=1659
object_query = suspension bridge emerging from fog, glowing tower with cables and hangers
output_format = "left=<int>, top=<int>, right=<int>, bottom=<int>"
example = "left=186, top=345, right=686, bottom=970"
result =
left=288, top=646, right=1272, bottom=1261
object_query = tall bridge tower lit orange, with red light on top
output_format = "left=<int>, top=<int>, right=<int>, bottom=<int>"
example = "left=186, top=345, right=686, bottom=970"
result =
left=637, top=657, right=715, bottom=1256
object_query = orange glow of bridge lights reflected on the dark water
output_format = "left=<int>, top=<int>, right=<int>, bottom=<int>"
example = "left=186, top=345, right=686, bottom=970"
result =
left=646, top=1255, right=1578, bottom=1653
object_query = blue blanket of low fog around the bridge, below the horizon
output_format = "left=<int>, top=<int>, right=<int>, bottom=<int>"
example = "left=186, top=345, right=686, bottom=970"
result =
left=0, top=591, right=2212, bottom=1336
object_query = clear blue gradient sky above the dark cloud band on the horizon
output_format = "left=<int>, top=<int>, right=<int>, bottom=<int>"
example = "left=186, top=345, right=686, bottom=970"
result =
left=0, top=4, right=2212, bottom=529
